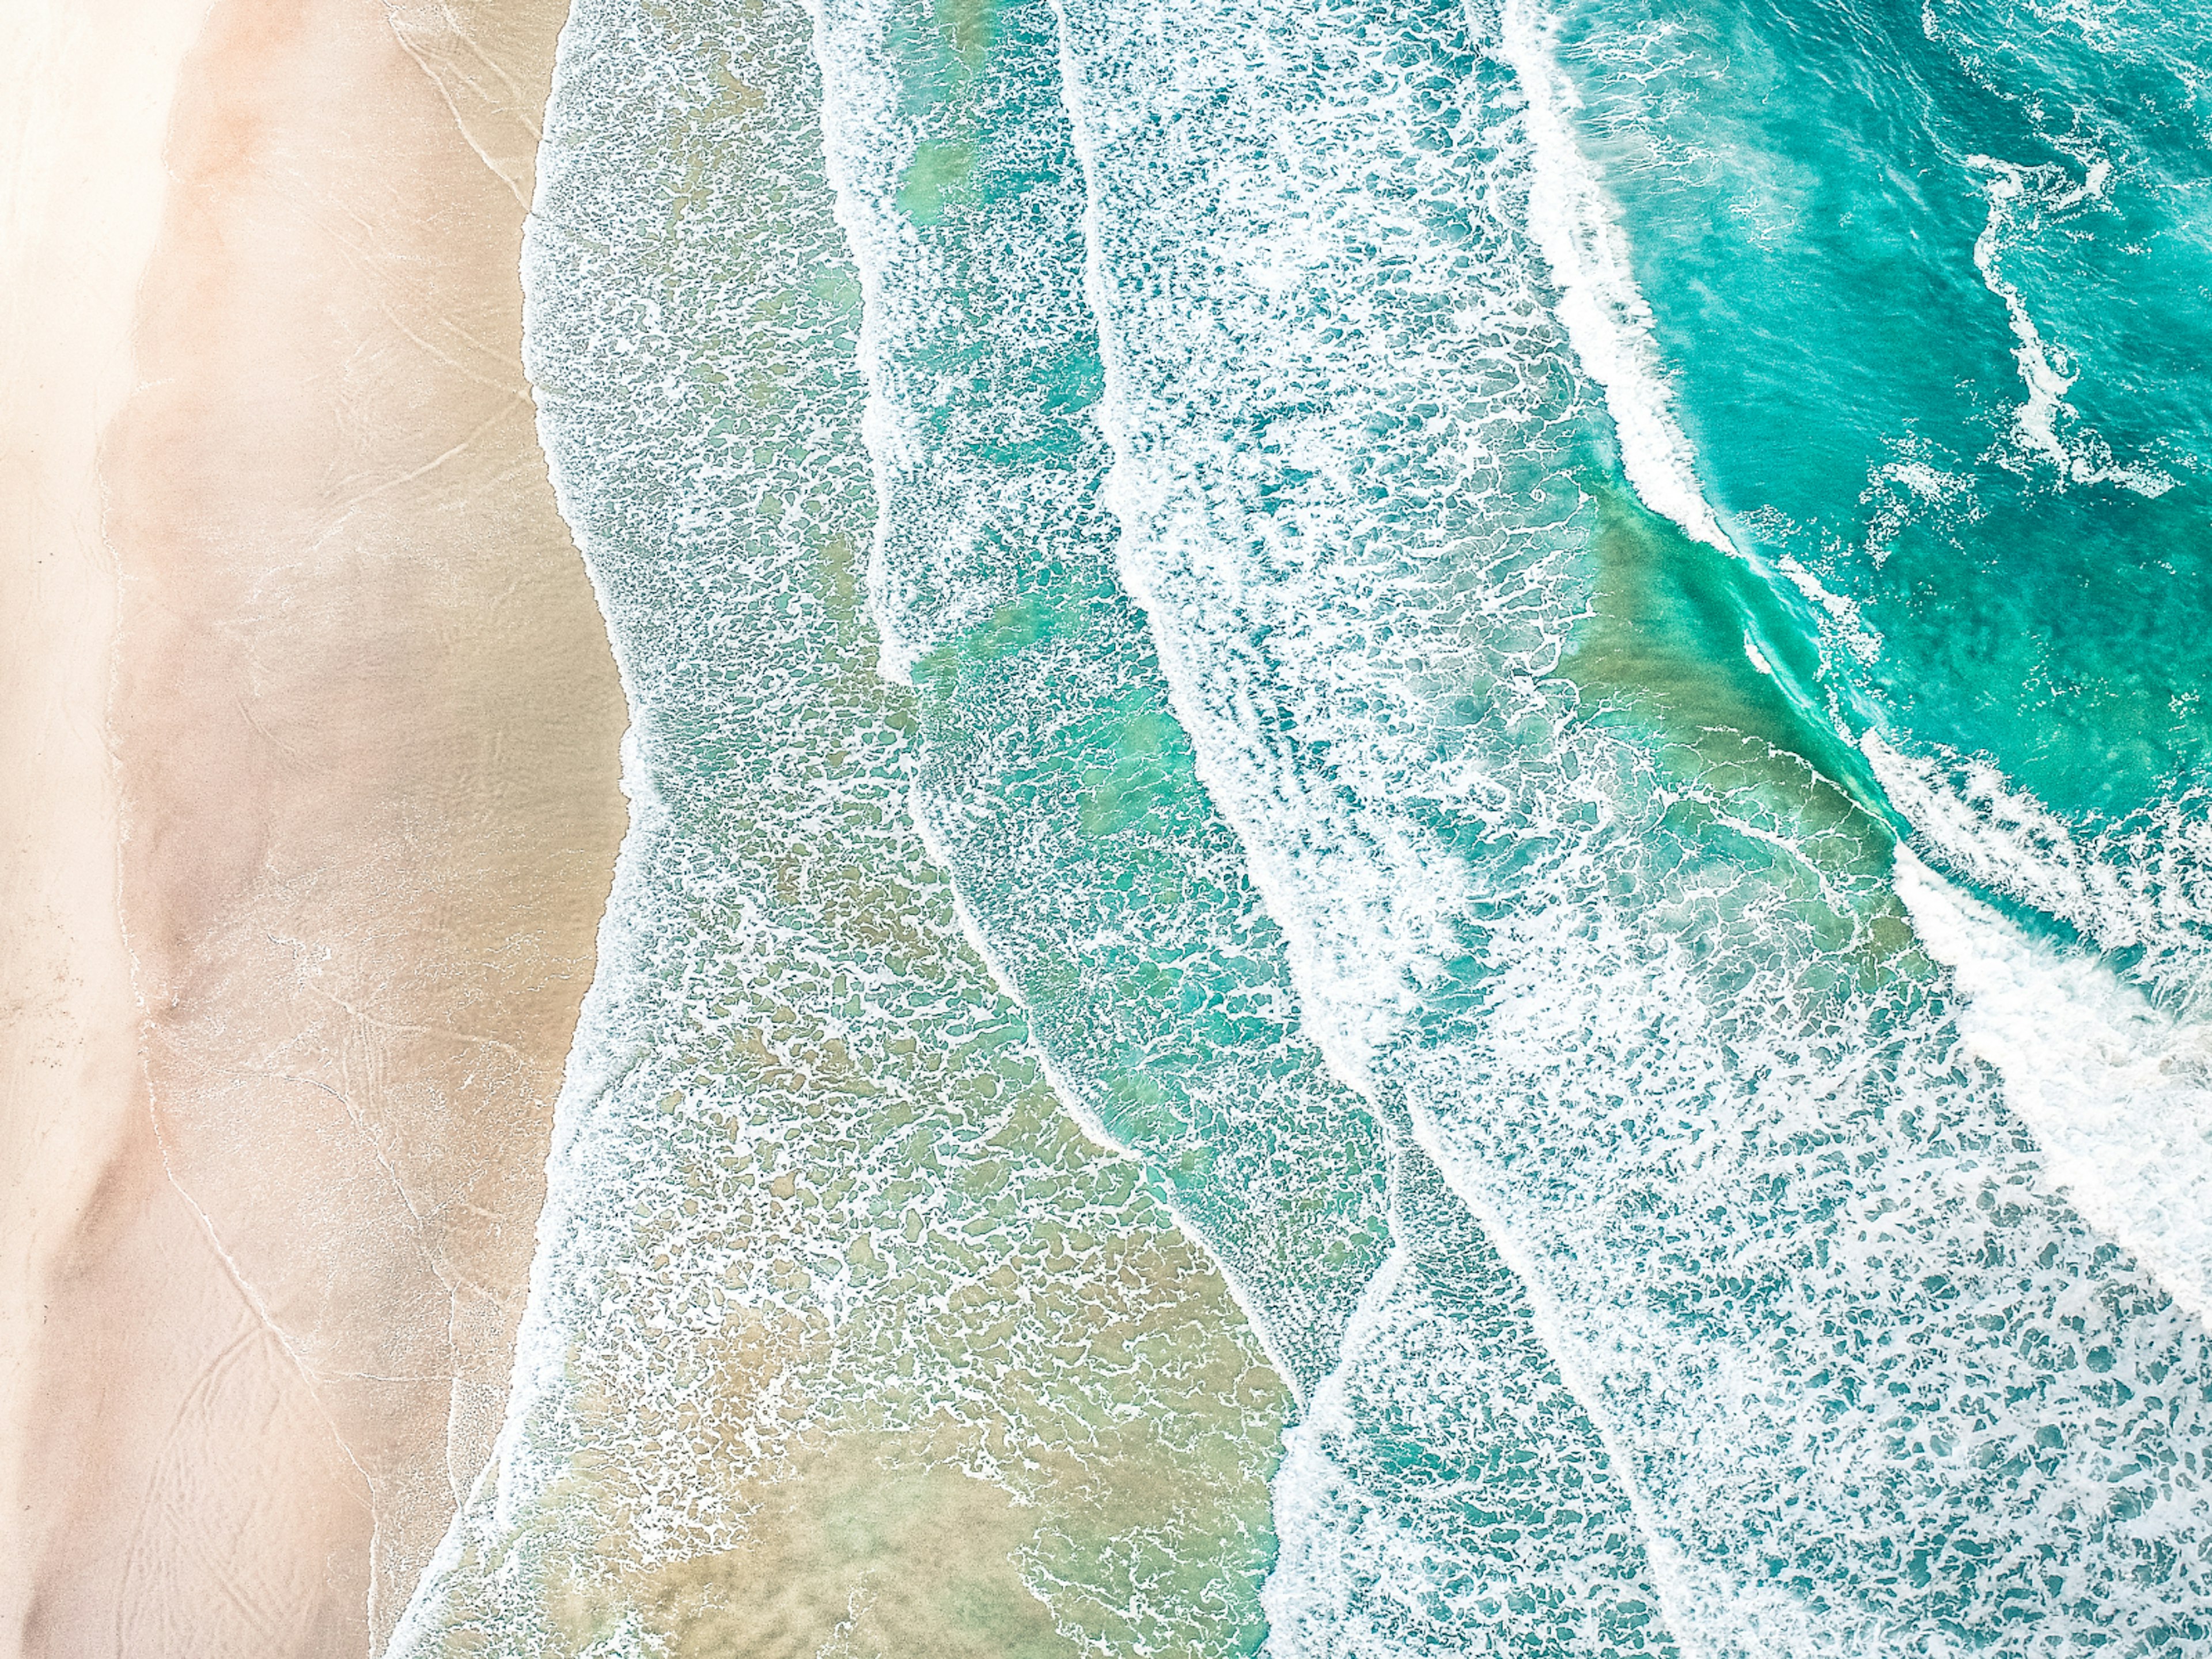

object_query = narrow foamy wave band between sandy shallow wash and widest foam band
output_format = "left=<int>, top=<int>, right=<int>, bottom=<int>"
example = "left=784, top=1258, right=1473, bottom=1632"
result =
left=814, top=0, right=1382, bottom=1400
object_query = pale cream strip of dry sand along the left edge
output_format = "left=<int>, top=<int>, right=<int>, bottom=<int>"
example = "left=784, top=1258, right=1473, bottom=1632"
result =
left=0, top=0, right=234, bottom=1652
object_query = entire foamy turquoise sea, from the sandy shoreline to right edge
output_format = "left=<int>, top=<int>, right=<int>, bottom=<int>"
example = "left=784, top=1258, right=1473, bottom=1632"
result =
left=394, top=0, right=2212, bottom=1659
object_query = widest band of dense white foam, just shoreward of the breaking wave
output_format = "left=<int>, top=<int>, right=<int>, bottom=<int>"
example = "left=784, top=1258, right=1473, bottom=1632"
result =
left=1064, top=0, right=2212, bottom=1657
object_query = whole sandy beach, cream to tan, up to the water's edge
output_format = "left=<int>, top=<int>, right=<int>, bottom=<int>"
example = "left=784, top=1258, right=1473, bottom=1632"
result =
left=0, top=0, right=624, bottom=1659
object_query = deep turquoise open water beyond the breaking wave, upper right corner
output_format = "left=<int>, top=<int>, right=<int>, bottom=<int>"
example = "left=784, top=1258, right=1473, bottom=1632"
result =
left=1559, top=5, right=2212, bottom=973
